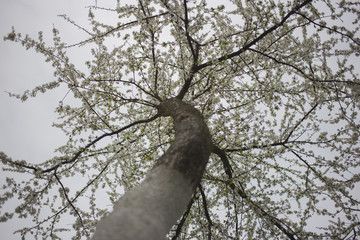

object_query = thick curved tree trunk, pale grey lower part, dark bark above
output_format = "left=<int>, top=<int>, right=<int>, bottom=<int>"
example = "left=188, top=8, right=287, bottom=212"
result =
left=93, top=98, right=212, bottom=240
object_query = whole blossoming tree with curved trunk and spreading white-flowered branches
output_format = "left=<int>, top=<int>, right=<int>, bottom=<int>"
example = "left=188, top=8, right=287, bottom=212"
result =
left=0, top=0, right=360, bottom=239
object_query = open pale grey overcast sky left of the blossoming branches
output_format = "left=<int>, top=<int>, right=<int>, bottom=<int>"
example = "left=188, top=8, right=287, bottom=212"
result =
left=0, top=0, right=102, bottom=239
